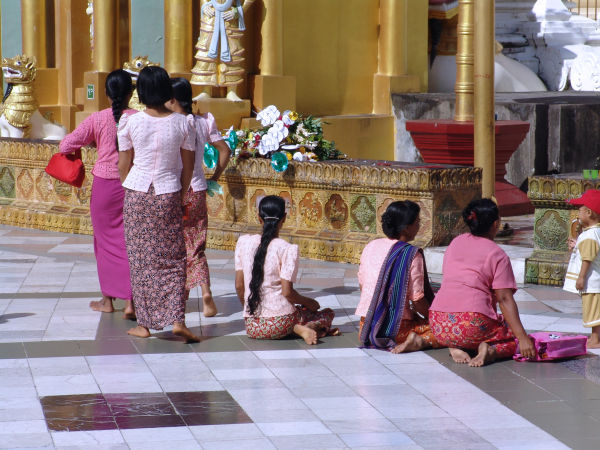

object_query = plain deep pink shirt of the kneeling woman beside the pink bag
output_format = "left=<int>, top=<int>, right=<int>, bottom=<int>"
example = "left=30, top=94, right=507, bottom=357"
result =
left=430, top=233, right=517, bottom=320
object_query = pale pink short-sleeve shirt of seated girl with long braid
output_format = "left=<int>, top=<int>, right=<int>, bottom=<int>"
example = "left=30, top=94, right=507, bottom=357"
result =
left=234, top=234, right=299, bottom=317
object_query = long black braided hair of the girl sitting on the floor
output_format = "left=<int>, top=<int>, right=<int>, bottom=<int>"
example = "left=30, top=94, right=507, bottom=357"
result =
left=248, top=195, right=285, bottom=315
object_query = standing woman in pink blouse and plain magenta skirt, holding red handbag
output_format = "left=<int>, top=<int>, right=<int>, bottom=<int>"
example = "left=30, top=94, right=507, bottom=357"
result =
left=60, top=69, right=136, bottom=319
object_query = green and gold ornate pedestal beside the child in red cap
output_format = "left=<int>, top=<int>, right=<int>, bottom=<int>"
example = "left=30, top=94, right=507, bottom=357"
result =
left=525, top=173, right=600, bottom=286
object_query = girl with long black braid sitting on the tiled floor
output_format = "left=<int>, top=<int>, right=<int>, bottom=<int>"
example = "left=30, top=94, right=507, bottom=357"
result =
left=235, top=195, right=338, bottom=345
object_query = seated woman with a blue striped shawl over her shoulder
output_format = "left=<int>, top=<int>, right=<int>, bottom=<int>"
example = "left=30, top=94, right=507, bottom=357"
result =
left=355, top=200, right=439, bottom=353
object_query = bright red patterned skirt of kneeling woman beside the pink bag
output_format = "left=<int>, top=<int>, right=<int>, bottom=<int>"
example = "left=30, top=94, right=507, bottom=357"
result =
left=429, top=311, right=517, bottom=358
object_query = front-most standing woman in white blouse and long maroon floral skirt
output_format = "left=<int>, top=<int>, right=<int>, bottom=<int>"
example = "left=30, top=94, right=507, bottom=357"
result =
left=118, top=66, right=199, bottom=342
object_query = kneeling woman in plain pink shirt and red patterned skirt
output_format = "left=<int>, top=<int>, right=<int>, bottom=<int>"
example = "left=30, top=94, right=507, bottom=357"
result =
left=429, top=198, right=535, bottom=367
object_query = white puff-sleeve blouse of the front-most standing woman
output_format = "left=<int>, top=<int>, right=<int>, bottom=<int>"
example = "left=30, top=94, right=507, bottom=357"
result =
left=117, top=112, right=196, bottom=195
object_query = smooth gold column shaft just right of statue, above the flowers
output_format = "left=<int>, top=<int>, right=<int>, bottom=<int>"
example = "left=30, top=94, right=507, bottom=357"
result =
left=259, top=0, right=283, bottom=76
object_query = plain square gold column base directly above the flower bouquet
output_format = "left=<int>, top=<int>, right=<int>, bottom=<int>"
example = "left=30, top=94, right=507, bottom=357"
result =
left=250, top=75, right=296, bottom=111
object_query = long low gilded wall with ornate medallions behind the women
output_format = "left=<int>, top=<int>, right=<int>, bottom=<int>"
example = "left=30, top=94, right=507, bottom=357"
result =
left=0, top=139, right=481, bottom=263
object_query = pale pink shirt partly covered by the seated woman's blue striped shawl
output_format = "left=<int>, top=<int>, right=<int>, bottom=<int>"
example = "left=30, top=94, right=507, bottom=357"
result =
left=354, top=238, right=425, bottom=320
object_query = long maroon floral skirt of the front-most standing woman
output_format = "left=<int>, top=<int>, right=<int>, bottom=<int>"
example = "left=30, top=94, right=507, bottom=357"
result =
left=123, top=186, right=186, bottom=330
